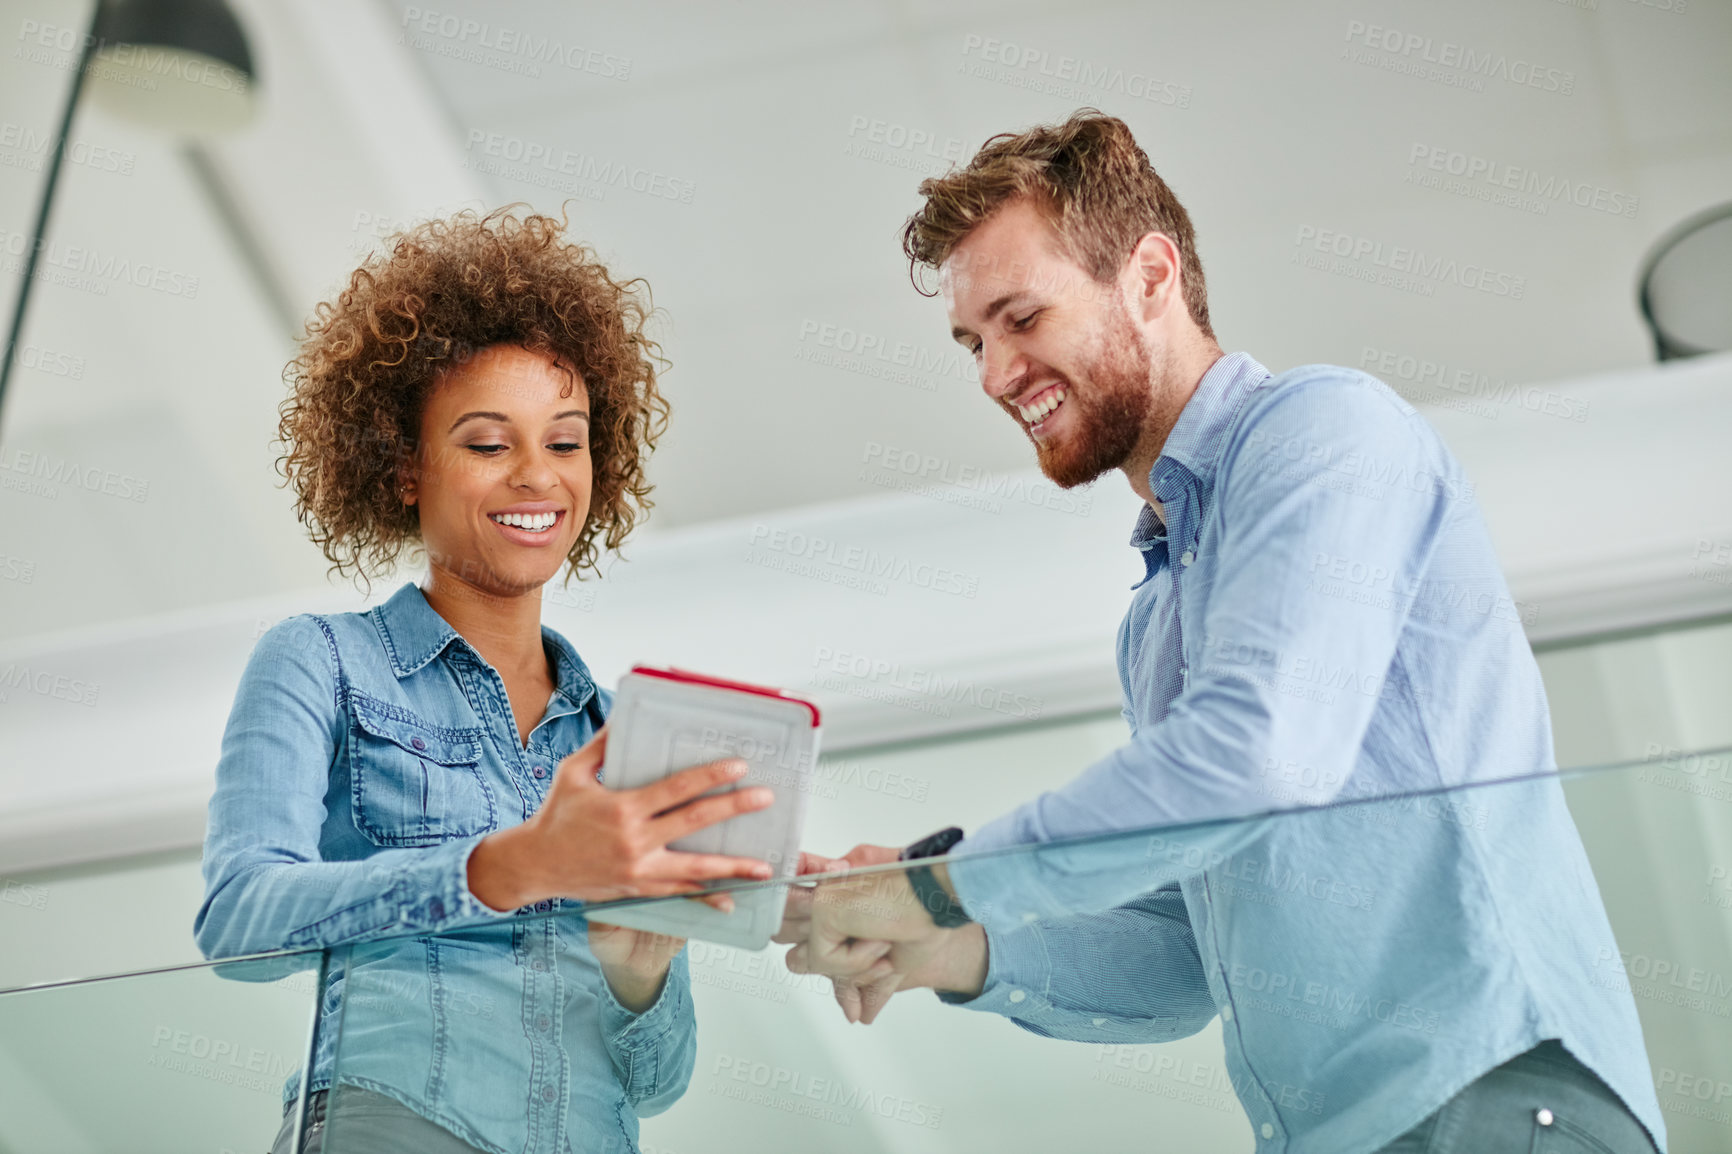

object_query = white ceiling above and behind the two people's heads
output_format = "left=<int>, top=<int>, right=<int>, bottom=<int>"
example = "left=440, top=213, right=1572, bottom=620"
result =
left=0, top=0, right=1732, bottom=638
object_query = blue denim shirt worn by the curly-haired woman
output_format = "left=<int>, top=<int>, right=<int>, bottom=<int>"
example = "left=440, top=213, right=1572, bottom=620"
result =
left=194, top=584, right=696, bottom=1154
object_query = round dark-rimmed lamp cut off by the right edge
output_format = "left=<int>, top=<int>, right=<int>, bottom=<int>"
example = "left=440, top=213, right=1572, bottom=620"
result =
left=1638, top=204, right=1732, bottom=360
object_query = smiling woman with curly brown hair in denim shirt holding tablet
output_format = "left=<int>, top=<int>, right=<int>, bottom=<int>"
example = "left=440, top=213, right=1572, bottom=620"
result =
left=194, top=210, right=771, bottom=1154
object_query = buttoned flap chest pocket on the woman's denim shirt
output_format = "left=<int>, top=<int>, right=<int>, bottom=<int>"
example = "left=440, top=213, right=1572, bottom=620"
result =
left=348, top=693, right=494, bottom=846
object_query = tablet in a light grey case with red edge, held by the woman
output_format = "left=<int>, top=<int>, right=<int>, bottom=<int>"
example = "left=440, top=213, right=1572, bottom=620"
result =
left=587, top=665, right=821, bottom=950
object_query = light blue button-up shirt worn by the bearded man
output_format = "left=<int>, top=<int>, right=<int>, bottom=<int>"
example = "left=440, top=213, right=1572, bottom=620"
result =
left=946, top=353, right=1664, bottom=1154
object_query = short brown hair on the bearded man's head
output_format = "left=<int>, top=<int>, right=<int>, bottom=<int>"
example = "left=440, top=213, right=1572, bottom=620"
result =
left=902, top=107, right=1214, bottom=340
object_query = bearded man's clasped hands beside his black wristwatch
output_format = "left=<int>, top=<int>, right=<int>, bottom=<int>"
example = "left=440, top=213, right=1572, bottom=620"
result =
left=776, top=846, right=987, bottom=1024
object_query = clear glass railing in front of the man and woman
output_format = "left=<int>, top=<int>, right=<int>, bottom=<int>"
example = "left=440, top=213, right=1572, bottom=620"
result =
left=0, top=749, right=1732, bottom=1154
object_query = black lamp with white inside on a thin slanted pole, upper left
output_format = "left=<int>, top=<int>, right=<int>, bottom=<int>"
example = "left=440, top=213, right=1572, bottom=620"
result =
left=0, top=0, right=256, bottom=426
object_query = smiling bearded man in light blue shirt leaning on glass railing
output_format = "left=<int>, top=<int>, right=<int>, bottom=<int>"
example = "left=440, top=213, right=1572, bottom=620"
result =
left=781, top=109, right=1664, bottom=1154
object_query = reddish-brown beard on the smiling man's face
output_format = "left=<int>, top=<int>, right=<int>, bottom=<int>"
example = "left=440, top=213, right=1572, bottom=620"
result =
left=1034, top=300, right=1152, bottom=489
